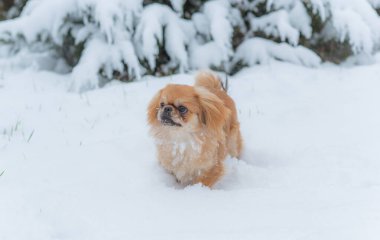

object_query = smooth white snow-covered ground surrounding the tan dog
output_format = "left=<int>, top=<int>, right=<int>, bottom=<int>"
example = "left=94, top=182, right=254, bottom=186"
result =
left=0, top=63, right=380, bottom=240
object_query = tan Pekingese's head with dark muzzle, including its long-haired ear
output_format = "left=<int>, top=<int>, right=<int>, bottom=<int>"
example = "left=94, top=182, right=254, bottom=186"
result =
left=148, top=84, right=228, bottom=131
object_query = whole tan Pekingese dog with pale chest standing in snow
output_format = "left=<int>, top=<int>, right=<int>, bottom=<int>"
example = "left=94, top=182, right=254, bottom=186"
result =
left=148, top=72, right=242, bottom=187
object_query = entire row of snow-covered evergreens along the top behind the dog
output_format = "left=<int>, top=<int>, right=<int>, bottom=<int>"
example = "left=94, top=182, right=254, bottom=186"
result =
left=0, top=0, right=380, bottom=90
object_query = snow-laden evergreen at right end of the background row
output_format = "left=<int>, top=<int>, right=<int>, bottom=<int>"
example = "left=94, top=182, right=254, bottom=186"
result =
left=233, top=0, right=380, bottom=70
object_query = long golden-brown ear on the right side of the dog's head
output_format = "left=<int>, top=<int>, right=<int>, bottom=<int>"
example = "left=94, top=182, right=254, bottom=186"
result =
left=195, top=87, right=230, bottom=131
